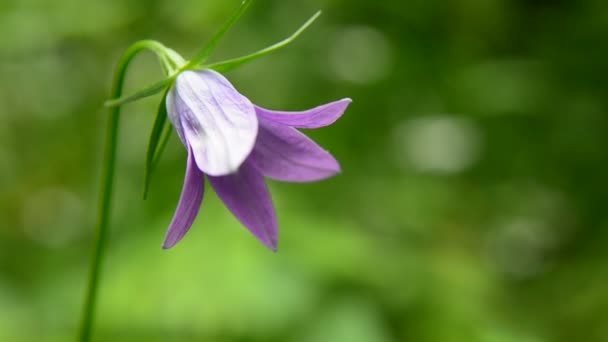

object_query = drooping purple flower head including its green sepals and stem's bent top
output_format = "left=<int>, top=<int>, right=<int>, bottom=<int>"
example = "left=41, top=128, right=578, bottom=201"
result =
left=106, top=0, right=351, bottom=250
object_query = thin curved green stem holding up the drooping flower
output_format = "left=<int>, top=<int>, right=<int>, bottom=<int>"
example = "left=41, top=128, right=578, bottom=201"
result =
left=79, top=40, right=171, bottom=342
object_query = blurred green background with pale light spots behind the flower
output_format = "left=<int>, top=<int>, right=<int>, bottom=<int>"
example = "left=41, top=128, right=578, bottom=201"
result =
left=0, top=0, right=608, bottom=342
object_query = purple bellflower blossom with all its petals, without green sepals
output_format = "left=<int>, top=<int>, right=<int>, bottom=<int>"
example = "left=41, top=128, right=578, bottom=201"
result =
left=163, top=69, right=351, bottom=250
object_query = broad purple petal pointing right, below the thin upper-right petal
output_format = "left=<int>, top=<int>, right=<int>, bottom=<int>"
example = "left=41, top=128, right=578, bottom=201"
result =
left=250, top=118, right=340, bottom=182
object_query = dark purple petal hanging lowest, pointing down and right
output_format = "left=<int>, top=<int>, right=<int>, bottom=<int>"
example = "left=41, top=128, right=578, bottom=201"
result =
left=209, top=161, right=278, bottom=251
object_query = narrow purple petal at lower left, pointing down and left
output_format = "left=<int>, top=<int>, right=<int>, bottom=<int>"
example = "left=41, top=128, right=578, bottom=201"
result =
left=163, top=148, right=205, bottom=249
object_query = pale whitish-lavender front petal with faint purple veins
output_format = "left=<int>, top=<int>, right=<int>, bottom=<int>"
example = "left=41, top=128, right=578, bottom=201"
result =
left=174, top=70, right=258, bottom=176
